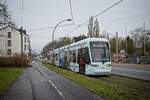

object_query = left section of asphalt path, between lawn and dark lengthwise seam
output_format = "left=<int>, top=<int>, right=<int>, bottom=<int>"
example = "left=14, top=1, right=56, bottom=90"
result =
left=0, top=68, right=33, bottom=100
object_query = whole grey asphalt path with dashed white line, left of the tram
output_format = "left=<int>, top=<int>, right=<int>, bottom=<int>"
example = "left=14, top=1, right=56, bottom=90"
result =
left=0, top=62, right=103, bottom=100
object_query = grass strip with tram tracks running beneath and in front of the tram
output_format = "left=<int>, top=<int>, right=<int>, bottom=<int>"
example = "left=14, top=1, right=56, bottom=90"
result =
left=43, top=64, right=150, bottom=100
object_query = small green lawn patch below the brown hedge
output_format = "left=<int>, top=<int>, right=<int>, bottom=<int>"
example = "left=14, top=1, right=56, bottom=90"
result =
left=0, top=67, right=23, bottom=94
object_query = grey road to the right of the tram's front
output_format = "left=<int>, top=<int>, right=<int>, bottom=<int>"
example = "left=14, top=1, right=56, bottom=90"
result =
left=112, top=64, right=150, bottom=81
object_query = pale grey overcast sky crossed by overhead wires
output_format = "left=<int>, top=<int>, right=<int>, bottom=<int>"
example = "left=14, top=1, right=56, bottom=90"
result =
left=7, top=0, right=150, bottom=51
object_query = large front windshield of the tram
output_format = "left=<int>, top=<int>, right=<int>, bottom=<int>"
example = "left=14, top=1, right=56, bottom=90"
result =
left=90, top=41, right=110, bottom=62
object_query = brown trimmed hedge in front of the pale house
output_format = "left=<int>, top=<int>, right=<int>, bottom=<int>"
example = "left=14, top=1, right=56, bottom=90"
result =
left=0, top=54, right=30, bottom=67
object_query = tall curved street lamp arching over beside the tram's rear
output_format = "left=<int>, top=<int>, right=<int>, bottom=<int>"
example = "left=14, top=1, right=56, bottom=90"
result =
left=52, top=19, right=72, bottom=64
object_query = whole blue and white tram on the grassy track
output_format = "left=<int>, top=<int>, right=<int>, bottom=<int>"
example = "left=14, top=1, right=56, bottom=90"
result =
left=50, top=38, right=111, bottom=75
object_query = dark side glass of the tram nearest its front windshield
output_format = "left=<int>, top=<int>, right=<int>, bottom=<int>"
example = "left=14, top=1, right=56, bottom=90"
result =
left=78, top=47, right=90, bottom=64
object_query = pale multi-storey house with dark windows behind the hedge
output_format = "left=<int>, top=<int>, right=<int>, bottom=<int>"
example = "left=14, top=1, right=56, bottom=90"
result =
left=0, top=25, right=31, bottom=56
